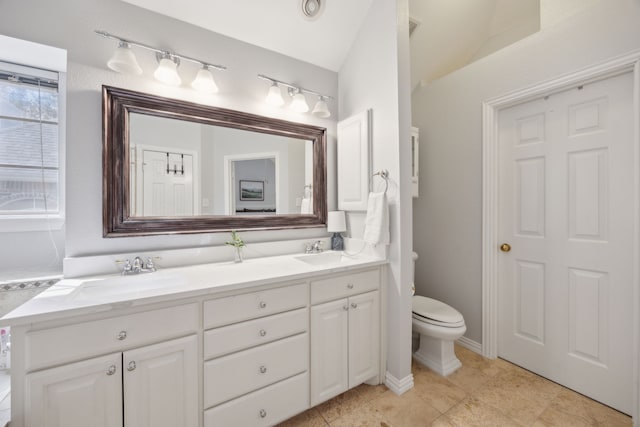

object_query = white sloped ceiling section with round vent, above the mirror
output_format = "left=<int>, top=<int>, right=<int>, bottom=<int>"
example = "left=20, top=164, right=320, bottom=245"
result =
left=124, top=0, right=372, bottom=71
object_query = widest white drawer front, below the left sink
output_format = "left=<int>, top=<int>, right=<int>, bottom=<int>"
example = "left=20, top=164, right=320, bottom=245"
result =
left=25, top=303, right=198, bottom=371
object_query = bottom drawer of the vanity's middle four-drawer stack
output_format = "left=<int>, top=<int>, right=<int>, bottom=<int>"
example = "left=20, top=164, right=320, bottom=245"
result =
left=204, top=372, right=309, bottom=427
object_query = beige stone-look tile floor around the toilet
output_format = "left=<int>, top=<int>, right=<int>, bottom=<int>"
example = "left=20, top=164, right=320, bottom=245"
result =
left=280, top=346, right=631, bottom=427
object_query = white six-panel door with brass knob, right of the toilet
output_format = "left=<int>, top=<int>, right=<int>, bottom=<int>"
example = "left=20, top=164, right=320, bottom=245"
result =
left=496, top=73, right=634, bottom=413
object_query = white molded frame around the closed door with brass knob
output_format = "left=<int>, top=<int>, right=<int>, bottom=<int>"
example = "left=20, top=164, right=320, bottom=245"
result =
left=482, top=51, right=640, bottom=427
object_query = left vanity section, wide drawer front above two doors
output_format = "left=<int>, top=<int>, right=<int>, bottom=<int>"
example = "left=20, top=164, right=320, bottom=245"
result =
left=20, top=304, right=199, bottom=427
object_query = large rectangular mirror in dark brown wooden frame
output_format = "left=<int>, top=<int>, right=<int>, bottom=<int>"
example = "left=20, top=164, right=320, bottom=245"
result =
left=102, top=86, right=327, bottom=237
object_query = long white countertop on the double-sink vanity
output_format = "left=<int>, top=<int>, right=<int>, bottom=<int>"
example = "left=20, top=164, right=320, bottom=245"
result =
left=0, top=251, right=387, bottom=326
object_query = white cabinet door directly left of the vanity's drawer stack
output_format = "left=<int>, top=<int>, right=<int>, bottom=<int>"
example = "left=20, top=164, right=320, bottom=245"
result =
left=122, top=335, right=198, bottom=427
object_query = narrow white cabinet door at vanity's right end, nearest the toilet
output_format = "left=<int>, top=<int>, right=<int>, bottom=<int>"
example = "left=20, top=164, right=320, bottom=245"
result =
left=349, top=291, right=380, bottom=388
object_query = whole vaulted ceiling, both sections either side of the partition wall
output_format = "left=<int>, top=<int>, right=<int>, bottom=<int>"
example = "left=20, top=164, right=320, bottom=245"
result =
left=123, top=0, right=540, bottom=88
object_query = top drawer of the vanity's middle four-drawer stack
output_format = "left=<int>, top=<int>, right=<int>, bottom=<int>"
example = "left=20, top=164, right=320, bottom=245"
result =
left=204, top=283, right=309, bottom=329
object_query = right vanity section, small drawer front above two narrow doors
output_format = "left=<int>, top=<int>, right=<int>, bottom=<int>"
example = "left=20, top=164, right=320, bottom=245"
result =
left=311, top=269, right=380, bottom=406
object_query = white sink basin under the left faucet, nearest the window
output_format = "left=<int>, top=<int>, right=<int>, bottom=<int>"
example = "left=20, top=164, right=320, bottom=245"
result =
left=71, top=273, right=185, bottom=300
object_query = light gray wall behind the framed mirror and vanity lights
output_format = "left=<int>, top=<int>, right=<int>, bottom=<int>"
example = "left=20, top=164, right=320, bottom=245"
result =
left=0, top=0, right=338, bottom=256
